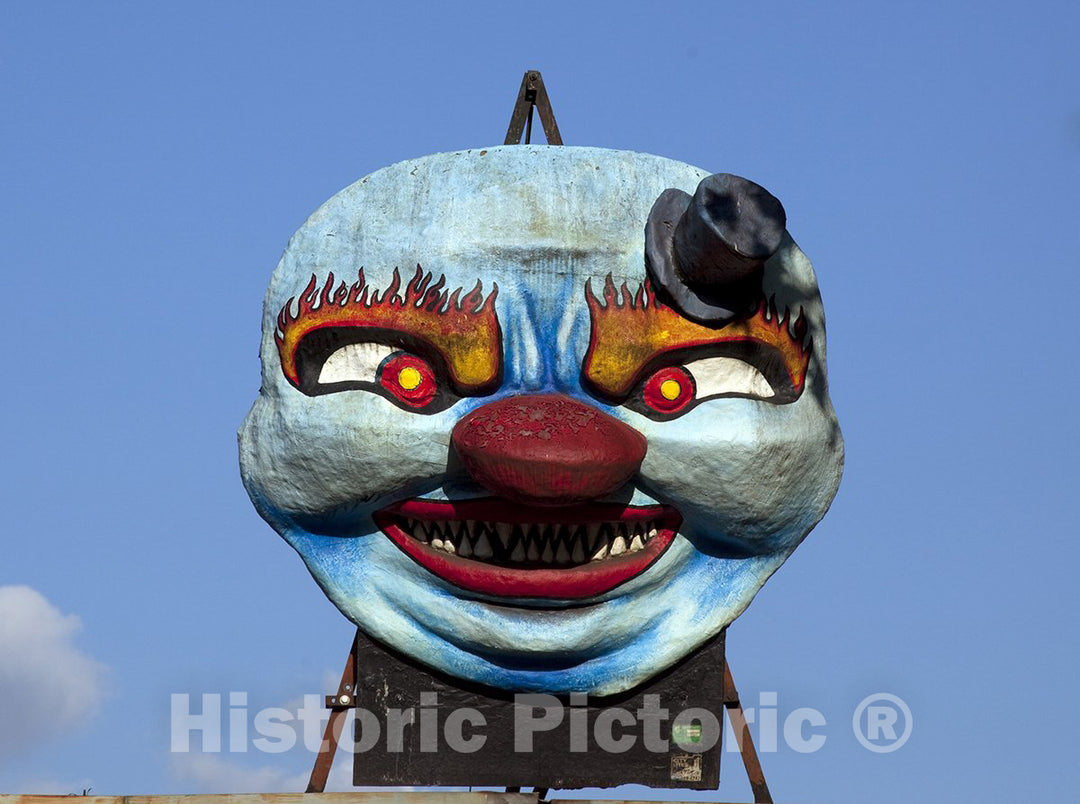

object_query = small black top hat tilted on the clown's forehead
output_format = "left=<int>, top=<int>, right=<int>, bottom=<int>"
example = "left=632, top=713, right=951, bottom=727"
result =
left=645, top=173, right=787, bottom=326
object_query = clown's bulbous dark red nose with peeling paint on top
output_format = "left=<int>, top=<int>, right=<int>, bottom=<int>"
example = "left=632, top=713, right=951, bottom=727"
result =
left=451, top=393, right=648, bottom=506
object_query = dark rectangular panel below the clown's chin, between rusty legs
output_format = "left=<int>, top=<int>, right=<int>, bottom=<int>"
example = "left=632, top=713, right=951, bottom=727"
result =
left=353, top=632, right=725, bottom=790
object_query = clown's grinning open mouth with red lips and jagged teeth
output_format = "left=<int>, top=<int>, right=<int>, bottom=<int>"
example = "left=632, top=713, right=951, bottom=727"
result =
left=375, top=498, right=681, bottom=600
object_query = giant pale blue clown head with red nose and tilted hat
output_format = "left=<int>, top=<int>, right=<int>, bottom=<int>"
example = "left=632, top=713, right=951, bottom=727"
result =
left=240, top=146, right=842, bottom=694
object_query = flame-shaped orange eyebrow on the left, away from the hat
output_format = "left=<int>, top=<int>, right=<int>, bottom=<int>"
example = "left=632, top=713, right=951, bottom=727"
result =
left=274, top=266, right=502, bottom=393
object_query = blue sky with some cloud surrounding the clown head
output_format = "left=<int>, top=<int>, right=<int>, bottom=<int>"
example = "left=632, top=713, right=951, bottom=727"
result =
left=0, top=2, right=1080, bottom=802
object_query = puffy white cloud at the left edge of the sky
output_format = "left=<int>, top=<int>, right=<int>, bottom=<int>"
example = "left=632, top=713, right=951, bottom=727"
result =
left=0, top=586, right=105, bottom=756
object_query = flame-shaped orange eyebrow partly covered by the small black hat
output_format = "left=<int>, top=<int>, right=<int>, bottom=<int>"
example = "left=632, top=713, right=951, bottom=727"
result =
left=581, top=274, right=812, bottom=400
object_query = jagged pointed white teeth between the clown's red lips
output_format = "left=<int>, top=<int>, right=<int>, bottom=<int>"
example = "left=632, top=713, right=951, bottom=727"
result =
left=401, top=519, right=660, bottom=568
